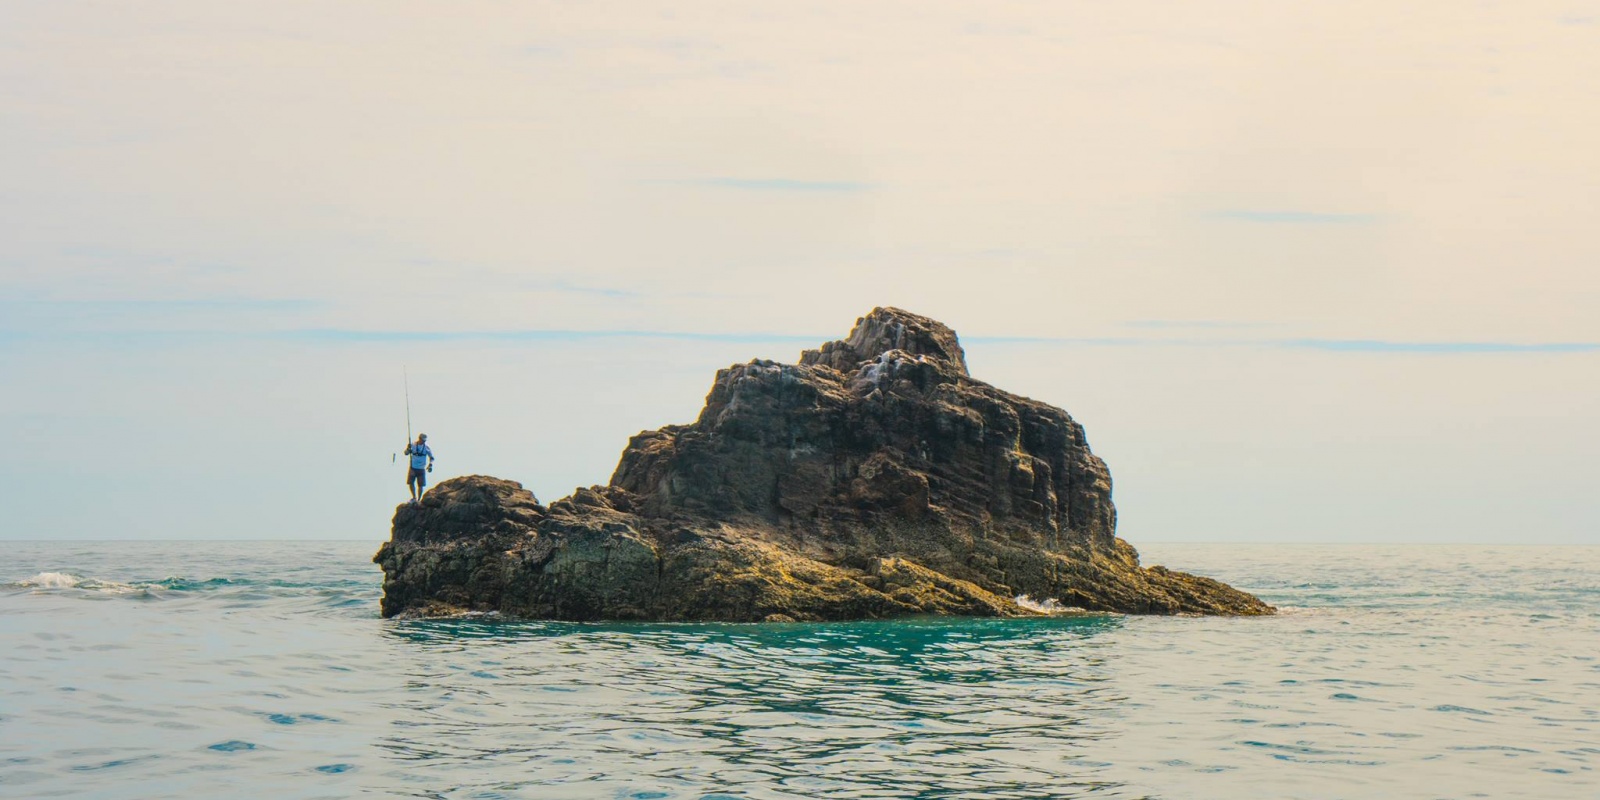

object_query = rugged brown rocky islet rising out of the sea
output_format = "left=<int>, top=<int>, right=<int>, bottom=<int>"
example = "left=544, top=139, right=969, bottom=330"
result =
left=373, top=309, right=1272, bottom=621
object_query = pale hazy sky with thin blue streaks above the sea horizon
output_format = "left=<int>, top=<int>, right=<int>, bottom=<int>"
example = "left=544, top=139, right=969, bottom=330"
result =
left=0, top=0, right=1600, bottom=544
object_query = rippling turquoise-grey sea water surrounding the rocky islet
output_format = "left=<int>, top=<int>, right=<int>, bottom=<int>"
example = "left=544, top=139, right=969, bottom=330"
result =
left=0, top=542, right=1600, bottom=800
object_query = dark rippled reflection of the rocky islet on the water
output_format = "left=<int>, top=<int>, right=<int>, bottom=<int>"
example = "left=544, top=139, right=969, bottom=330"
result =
left=379, top=616, right=1123, bottom=798
